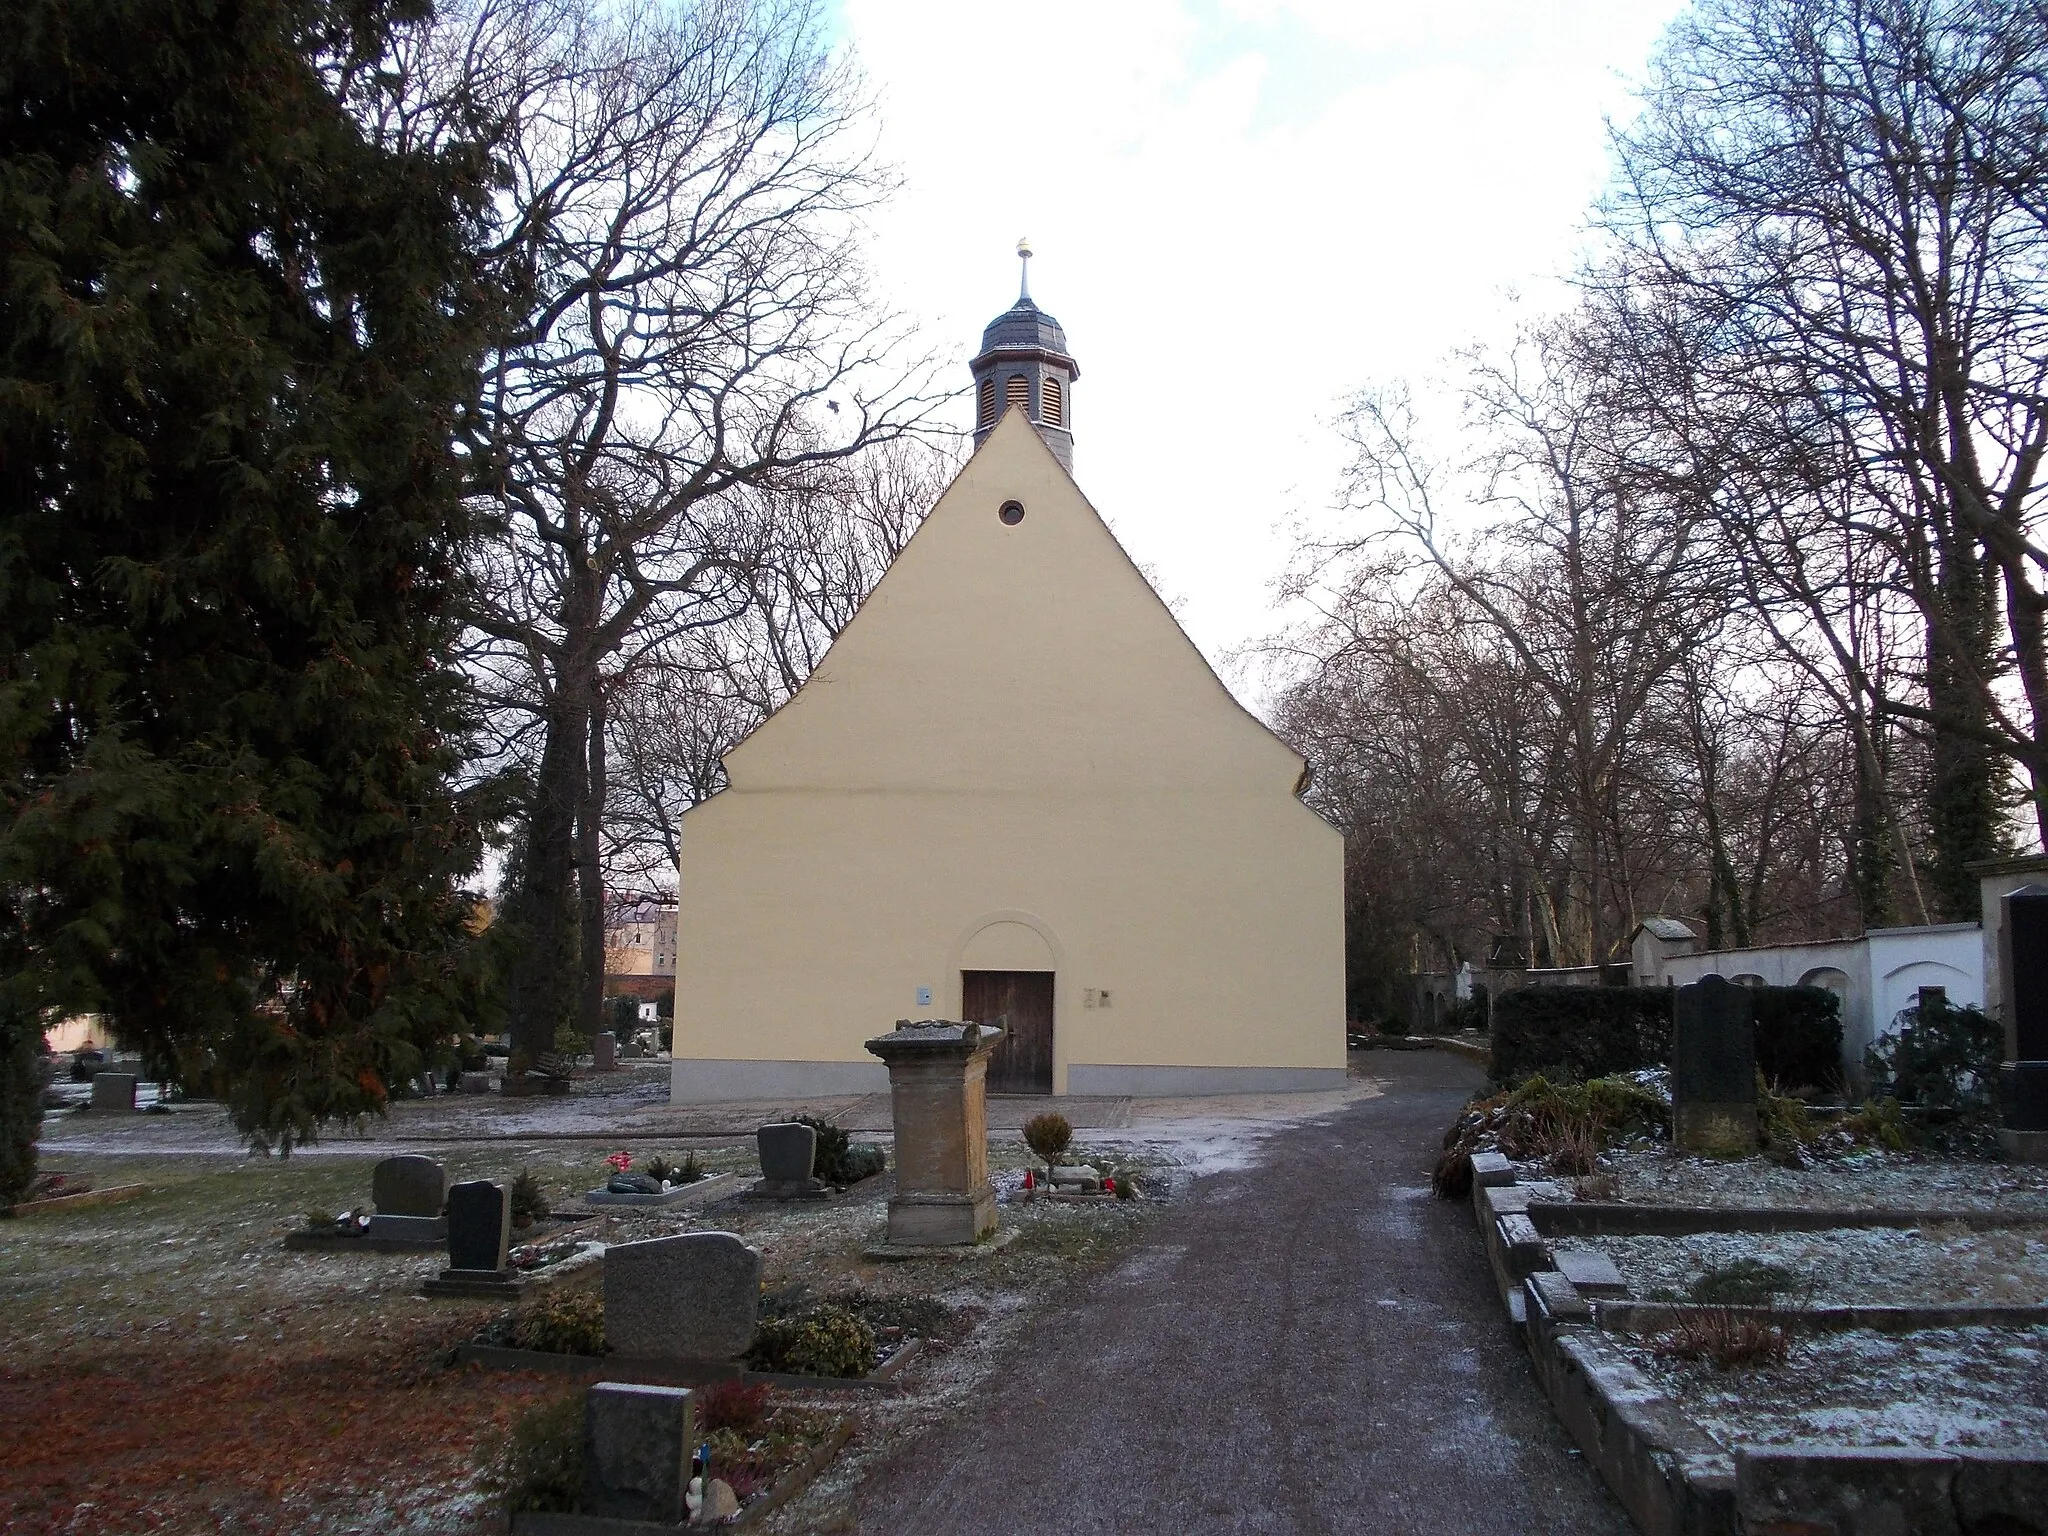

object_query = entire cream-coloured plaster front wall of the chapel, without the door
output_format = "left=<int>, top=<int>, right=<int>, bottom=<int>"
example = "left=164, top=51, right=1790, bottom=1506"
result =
left=672, top=412, right=1343, bottom=1102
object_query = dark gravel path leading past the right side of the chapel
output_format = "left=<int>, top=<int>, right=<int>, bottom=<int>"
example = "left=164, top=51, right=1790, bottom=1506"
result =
left=858, top=1053, right=1632, bottom=1536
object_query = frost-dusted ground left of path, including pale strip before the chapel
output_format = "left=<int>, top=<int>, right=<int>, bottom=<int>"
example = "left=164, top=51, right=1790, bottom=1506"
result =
left=0, top=1071, right=1335, bottom=1536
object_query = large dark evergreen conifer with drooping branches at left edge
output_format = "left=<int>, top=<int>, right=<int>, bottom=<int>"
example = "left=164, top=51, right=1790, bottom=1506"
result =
left=0, top=0, right=487, bottom=1149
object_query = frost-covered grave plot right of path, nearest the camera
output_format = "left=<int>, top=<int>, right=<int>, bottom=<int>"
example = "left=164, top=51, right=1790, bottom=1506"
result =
left=1610, top=1327, right=2048, bottom=1454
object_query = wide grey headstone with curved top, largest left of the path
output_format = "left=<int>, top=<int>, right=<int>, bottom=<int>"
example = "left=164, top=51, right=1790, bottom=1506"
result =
left=604, top=1233, right=762, bottom=1360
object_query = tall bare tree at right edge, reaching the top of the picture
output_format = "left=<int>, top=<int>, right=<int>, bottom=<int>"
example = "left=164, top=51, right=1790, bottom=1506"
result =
left=1606, top=0, right=2048, bottom=913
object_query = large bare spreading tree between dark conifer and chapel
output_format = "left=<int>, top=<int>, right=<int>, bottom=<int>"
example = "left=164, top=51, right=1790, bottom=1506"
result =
left=449, top=0, right=932, bottom=1057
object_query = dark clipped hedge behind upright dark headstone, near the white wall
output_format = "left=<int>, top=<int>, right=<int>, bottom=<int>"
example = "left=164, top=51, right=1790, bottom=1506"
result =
left=1493, top=987, right=1841, bottom=1090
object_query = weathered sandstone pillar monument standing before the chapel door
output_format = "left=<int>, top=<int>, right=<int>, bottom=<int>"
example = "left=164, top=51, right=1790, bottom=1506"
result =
left=868, top=1020, right=1004, bottom=1247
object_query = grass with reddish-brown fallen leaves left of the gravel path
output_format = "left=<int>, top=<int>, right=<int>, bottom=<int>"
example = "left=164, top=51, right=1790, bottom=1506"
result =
left=0, top=1133, right=1163, bottom=1536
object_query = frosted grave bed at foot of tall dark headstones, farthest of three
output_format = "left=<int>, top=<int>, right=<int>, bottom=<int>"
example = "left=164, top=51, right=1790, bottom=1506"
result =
left=1602, top=1147, right=2048, bottom=1221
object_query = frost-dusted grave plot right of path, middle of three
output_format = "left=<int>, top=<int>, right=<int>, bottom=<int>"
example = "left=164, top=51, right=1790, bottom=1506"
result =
left=1559, top=1223, right=2048, bottom=1307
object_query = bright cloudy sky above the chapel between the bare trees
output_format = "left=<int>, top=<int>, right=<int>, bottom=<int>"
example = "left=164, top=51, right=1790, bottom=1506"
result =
left=834, top=0, right=1679, bottom=688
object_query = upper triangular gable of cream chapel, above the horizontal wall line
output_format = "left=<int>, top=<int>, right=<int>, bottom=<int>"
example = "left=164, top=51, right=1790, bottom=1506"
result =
left=725, top=412, right=1303, bottom=793
